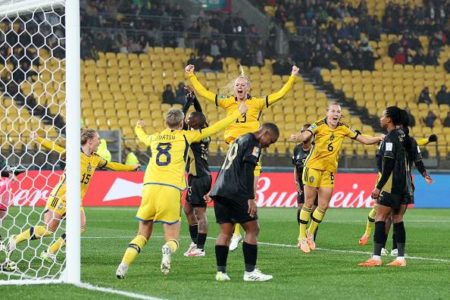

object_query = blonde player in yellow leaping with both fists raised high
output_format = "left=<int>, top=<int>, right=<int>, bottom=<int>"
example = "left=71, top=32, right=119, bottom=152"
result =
left=185, top=65, right=299, bottom=251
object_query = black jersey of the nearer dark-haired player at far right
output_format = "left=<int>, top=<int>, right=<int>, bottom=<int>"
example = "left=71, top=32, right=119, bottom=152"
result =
left=378, top=129, right=411, bottom=195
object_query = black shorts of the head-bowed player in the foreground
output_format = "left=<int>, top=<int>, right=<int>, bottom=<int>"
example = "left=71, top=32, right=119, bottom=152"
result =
left=213, top=196, right=258, bottom=224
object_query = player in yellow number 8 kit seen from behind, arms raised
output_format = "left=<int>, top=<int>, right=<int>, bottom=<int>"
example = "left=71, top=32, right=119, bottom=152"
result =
left=116, top=103, right=247, bottom=279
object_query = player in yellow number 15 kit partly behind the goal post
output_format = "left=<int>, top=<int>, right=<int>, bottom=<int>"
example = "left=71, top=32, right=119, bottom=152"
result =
left=8, top=129, right=139, bottom=261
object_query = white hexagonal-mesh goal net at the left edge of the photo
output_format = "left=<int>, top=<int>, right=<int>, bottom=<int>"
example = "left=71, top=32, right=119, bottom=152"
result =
left=0, top=0, right=79, bottom=284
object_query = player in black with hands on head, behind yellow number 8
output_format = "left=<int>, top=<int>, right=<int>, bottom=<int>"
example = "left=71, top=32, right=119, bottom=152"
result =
left=183, top=91, right=211, bottom=257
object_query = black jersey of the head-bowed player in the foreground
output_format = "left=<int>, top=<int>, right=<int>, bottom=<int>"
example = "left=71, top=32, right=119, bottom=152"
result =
left=211, top=133, right=261, bottom=200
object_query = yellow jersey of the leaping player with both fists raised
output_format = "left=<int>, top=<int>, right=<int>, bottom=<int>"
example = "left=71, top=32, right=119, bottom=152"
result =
left=188, top=72, right=296, bottom=144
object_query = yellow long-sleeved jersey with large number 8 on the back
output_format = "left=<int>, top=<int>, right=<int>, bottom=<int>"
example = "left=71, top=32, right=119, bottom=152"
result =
left=134, top=110, right=241, bottom=190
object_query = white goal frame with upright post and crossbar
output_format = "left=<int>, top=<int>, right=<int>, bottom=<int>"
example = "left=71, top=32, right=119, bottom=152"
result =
left=0, top=0, right=81, bottom=285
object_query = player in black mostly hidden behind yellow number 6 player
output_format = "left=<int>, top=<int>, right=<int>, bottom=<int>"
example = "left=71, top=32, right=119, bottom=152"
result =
left=292, top=124, right=318, bottom=226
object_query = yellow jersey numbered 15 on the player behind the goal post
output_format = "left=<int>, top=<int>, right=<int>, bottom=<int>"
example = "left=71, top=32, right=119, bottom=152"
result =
left=36, top=137, right=134, bottom=201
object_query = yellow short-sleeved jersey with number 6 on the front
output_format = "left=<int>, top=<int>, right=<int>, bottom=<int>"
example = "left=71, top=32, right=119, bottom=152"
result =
left=305, top=118, right=358, bottom=173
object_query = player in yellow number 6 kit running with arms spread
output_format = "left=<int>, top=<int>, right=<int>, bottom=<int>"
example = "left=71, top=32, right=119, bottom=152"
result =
left=291, top=103, right=382, bottom=253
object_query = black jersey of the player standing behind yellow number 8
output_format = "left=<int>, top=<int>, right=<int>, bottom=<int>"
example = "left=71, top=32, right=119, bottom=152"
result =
left=189, top=137, right=211, bottom=177
